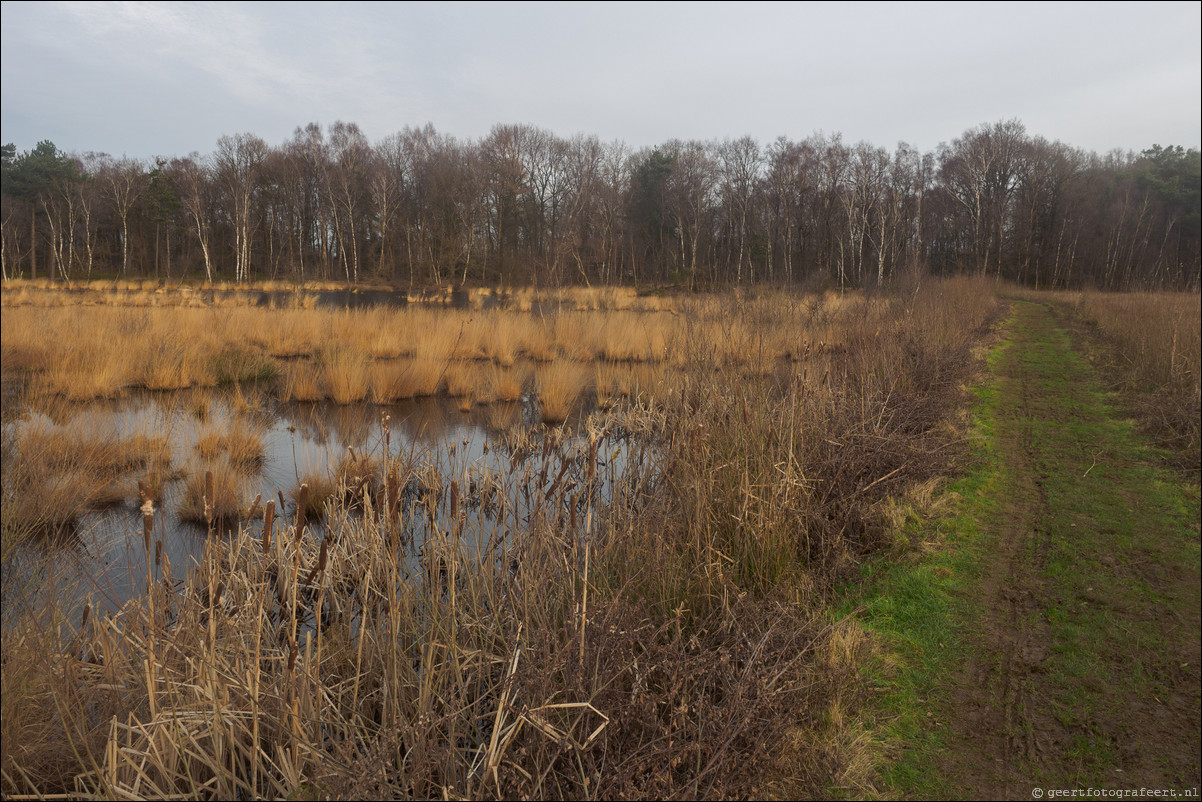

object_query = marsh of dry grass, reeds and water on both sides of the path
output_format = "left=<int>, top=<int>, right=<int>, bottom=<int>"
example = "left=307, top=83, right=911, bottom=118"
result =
left=0, top=279, right=1200, bottom=798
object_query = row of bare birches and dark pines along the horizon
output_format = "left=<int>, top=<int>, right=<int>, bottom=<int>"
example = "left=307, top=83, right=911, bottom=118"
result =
left=0, top=120, right=1202, bottom=290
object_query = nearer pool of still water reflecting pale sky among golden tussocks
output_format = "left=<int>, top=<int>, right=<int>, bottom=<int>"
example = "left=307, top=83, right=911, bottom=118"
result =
left=4, top=390, right=653, bottom=619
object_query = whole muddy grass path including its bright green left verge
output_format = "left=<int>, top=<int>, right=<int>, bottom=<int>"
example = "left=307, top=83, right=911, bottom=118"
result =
left=857, top=303, right=1202, bottom=798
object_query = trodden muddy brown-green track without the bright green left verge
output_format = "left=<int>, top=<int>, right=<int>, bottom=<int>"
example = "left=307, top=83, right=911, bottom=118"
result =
left=941, top=304, right=1202, bottom=798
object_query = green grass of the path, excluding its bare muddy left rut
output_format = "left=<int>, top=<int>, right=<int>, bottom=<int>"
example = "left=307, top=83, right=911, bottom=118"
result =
left=839, top=303, right=1202, bottom=798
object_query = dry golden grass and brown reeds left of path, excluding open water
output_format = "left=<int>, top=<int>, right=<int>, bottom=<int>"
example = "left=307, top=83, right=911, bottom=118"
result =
left=0, top=280, right=1014, bottom=798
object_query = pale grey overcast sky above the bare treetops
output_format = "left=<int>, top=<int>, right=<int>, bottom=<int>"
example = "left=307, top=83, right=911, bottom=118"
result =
left=0, top=1, right=1202, bottom=158
